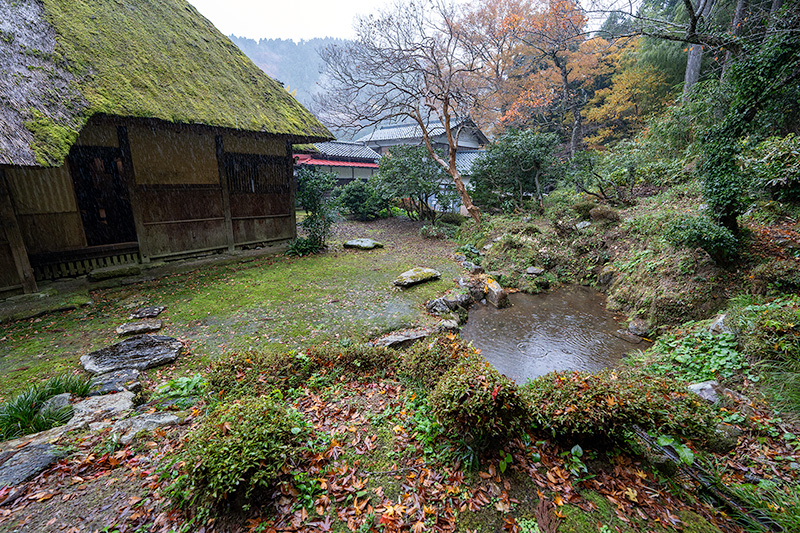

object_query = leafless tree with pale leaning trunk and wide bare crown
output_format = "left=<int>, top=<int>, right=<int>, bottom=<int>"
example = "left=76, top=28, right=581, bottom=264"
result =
left=315, top=0, right=480, bottom=222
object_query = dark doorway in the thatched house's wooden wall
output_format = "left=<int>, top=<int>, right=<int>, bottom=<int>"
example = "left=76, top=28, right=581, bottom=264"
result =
left=69, top=146, right=136, bottom=246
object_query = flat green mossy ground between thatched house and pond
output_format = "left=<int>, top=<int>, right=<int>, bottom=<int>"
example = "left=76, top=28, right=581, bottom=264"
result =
left=0, top=216, right=460, bottom=397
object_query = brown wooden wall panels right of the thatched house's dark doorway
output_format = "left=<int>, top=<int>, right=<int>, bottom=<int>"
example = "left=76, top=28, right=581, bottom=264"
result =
left=128, top=123, right=296, bottom=258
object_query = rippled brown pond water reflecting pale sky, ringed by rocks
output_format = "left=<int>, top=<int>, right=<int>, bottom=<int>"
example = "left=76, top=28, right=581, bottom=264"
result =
left=461, top=286, right=644, bottom=383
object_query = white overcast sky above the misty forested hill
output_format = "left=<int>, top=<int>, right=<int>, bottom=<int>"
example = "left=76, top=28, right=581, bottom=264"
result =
left=184, top=0, right=388, bottom=41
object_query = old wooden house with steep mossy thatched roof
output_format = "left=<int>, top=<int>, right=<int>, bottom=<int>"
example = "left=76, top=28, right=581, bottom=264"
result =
left=0, top=0, right=332, bottom=291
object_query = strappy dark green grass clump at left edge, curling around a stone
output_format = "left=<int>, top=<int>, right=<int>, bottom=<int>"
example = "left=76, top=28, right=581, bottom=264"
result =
left=0, top=375, right=92, bottom=440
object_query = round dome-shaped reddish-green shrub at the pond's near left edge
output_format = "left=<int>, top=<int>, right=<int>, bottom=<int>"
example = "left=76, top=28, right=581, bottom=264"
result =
left=428, top=359, right=526, bottom=448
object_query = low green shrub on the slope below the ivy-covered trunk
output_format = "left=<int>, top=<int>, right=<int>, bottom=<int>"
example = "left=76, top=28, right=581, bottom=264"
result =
left=664, top=212, right=737, bottom=263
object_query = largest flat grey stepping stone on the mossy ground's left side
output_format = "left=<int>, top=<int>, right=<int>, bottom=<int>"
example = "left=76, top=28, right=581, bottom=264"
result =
left=81, top=335, right=183, bottom=374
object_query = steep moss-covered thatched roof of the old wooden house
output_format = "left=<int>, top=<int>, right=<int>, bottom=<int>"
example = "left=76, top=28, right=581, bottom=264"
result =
left=0, top=0, right=332, bottom=166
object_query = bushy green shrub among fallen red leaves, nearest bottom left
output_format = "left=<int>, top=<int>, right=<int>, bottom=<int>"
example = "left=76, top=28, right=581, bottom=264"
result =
left=168, top=396, right=308, bottom=516
